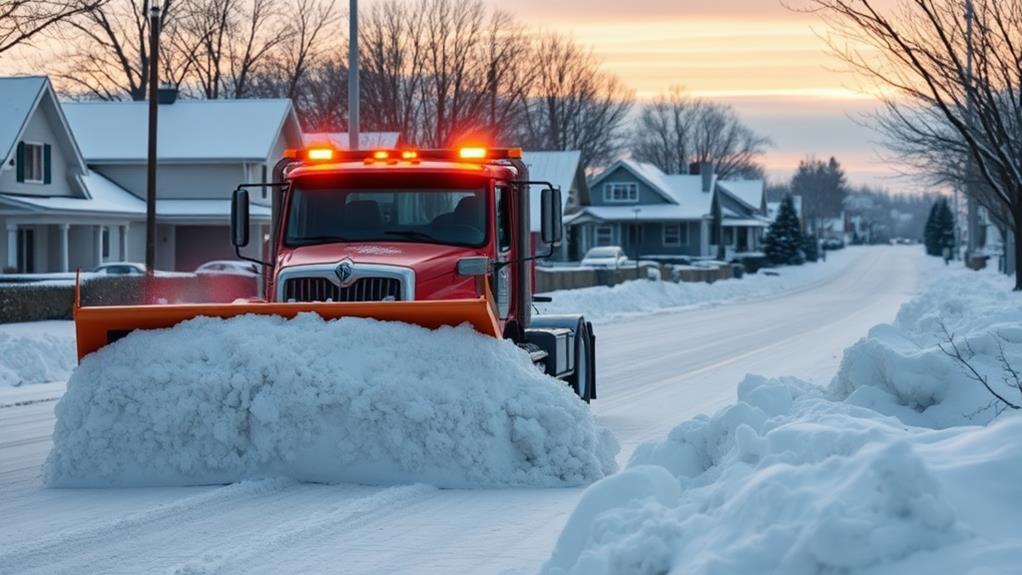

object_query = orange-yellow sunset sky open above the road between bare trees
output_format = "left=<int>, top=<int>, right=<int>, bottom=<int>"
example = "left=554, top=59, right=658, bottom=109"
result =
left=486, top=0, right=911, bottom=190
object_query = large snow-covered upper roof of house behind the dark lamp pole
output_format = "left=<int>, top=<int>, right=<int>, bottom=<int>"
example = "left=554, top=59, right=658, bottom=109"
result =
left=63, top=99, right=297, bottom=162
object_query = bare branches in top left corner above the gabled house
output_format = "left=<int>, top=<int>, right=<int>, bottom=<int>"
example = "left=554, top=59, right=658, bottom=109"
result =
left=0, top=0, right=106, bottom=54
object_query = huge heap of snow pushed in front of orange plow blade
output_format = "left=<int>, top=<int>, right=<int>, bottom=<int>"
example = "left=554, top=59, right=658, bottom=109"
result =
left=44, top=315, right=617, bottom=487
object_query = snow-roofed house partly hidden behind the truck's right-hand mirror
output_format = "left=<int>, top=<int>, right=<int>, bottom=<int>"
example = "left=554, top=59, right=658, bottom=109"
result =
left=522, top=150, right=589, bottom=260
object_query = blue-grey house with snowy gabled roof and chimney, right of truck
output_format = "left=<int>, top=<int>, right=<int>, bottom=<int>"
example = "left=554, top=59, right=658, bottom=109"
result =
left=566, top=159, right=769, bottom=259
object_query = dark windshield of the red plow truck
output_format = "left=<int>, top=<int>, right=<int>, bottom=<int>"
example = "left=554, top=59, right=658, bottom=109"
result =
left=285, top=187, right=486, bottom=247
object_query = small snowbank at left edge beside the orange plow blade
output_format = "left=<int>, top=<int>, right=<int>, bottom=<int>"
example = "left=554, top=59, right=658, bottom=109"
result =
left=0, top=322, right=75, bottom=386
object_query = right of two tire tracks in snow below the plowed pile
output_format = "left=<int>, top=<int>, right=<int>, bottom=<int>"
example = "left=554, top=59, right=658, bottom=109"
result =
left=170, top=484, right=438, bottom=575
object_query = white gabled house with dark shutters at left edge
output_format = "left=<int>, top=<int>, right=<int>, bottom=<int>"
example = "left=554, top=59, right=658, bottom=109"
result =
left=0, top=77, right=145, bottom=273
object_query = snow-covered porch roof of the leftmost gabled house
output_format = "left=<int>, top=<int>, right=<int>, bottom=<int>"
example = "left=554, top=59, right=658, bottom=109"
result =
left=0, top=172, right=145, bottom=218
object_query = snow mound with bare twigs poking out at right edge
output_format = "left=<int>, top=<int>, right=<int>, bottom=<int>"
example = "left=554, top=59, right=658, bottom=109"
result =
left=829, top=270, right=1022, bottom=428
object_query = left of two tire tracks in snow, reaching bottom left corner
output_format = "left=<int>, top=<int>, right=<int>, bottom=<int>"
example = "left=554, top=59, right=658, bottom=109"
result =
left=0, top=479, right=296, bottom=575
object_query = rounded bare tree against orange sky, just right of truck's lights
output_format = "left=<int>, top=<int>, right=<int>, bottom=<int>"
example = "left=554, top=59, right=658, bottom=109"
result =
left=521, top=35, right=632, bottom=166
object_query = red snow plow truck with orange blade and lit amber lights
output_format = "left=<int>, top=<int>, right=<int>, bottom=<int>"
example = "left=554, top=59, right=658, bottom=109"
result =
left=75, top=147, right=596, bottom=401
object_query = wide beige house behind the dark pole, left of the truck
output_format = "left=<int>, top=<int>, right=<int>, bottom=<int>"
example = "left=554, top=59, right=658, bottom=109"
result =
left=63, top=93, right=303, bottom=271
